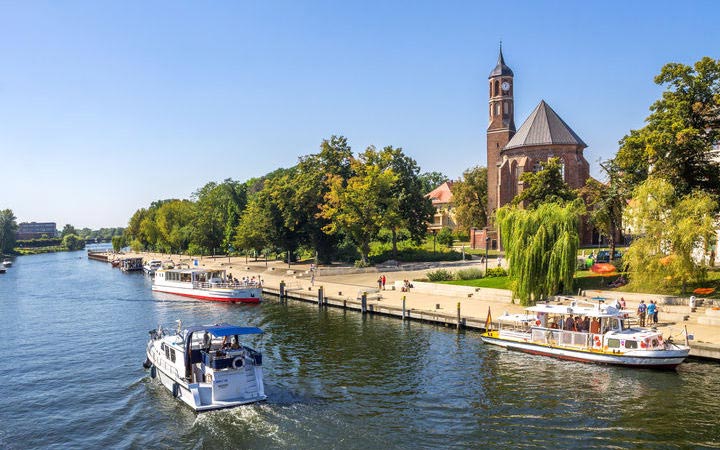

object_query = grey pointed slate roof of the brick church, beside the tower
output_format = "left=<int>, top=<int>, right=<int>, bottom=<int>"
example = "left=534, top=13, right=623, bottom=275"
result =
left=504, top=100, right=587, bottom=150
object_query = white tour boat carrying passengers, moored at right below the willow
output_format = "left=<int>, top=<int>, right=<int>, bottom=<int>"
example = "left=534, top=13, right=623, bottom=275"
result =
left=481, top=300, right=690, bottom=369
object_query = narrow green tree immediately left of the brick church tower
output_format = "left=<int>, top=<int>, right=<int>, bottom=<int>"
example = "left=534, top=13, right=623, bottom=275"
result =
left=452, top=166, right=488, bottom=230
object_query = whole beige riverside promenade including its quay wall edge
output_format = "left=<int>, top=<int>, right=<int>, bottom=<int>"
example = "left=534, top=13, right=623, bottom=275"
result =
left=118, top=253, right=720, bottom=361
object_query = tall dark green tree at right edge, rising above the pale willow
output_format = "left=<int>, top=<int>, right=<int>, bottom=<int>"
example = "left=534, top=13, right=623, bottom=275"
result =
left=611, top=57, right=720, bottom=197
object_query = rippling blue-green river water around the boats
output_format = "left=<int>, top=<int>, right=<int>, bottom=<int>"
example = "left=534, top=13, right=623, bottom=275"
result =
left=0, top=252, right=720, bottom=449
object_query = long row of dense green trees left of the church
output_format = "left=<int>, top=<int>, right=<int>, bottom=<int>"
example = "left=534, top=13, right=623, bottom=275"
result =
left=123, top=136, right=446, bottom=264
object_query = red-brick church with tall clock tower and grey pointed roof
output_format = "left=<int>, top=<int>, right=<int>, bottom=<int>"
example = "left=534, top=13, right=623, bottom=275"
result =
left=471, top=47, right=592, bottom=248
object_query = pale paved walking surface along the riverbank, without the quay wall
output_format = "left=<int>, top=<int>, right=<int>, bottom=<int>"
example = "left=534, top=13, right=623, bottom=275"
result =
left=118, top=253, right=720, bottom=354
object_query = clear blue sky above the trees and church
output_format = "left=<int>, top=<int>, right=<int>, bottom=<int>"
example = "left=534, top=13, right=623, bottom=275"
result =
left=0, top=1, right=720, bottom=228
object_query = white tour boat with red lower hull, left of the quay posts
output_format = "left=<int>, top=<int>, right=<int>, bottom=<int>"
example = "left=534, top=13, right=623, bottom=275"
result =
left=152, top=269, right=262, bottom=303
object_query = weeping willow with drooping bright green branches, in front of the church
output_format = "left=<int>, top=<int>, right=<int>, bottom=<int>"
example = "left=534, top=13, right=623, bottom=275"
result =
left=497, top=201, right=582, bottom=305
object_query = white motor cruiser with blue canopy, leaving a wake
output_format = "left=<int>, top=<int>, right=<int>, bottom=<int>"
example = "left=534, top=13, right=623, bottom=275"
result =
left=143, top=321, right=267, bottom=412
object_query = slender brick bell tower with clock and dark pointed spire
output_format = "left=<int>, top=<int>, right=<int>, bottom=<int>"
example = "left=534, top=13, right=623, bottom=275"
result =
left=487, top=44, right=515, bottom=221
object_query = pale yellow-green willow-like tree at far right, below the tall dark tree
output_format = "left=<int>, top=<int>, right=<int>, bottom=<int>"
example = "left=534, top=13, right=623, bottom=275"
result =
left=624, top=176, right=718, bottom=292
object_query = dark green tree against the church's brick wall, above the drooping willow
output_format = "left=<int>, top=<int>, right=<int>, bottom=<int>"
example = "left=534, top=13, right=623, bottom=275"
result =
left=512, top=158, right=577, bottom=209
